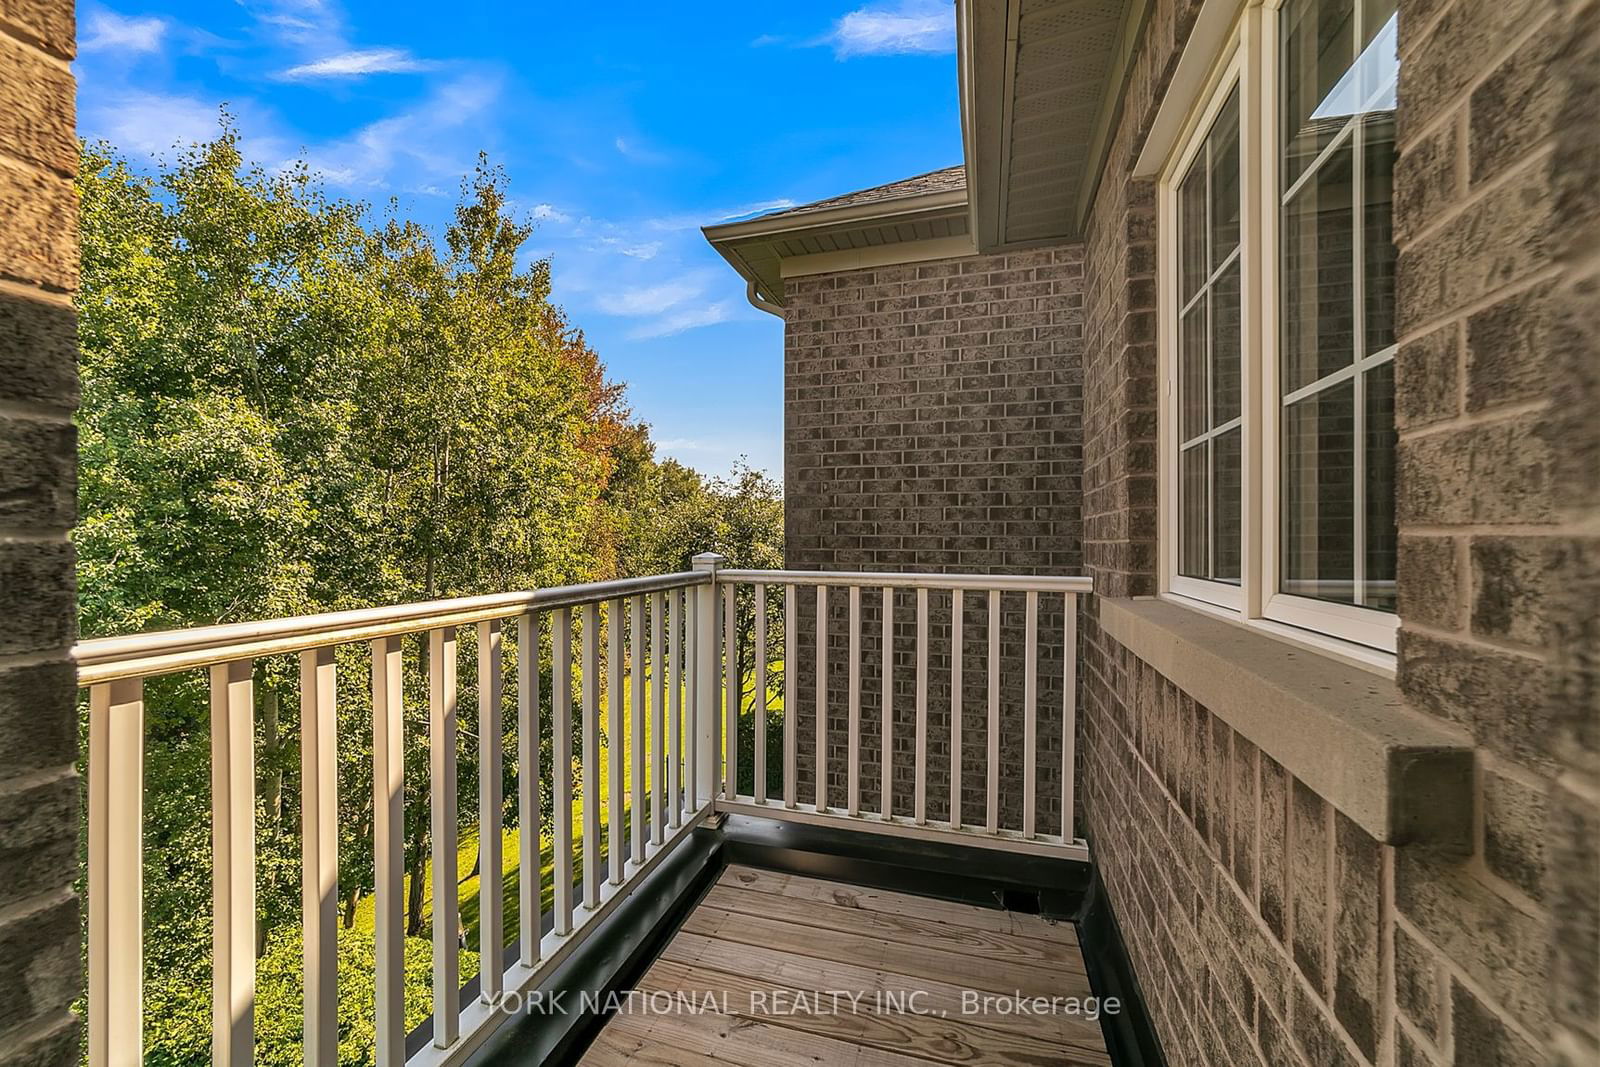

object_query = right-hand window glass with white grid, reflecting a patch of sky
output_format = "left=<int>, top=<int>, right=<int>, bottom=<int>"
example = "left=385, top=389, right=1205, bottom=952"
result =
left=1278, top=0, right=1400, bottom=611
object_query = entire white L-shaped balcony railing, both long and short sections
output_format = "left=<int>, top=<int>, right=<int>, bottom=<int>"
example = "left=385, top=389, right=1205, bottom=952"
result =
left=77, top=553, right=1090, bottom=1067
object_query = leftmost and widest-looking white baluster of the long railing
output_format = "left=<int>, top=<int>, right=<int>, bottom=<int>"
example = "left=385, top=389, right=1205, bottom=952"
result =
left=88, top=678, right=144, bottom=1067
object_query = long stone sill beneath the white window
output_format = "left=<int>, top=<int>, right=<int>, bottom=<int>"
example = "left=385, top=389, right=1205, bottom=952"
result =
left=1094, top=597, right=1474, bottom=849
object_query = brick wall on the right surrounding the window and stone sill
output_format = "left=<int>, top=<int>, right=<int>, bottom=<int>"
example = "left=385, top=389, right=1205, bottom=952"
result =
left=1080, top=0, right=1600, bottom=1067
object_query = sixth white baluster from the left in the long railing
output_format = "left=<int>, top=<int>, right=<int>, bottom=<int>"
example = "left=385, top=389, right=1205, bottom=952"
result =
left=478, top=619, right=506, bottom=1005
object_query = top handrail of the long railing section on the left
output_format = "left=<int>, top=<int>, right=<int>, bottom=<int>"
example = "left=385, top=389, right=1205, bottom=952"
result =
left=72, top=571, right=710, bottom=685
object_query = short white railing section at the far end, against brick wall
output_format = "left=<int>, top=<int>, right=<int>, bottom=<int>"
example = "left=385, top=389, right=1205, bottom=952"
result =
left=699, top=569, right=1093, bottom=859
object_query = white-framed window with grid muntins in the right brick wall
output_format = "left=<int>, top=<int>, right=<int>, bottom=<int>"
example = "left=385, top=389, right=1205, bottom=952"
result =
left=1160, top=0, right=1398, bottom=651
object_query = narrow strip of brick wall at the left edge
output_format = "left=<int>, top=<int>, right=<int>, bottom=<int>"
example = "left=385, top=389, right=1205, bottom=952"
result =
left=0, top=0, right=82, bottom=1065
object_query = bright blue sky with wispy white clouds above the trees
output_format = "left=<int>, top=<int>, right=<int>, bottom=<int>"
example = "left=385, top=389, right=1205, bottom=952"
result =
left=75, top=0, right=960, bottom=474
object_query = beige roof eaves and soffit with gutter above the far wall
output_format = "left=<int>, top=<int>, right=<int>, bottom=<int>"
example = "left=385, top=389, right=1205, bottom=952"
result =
left=704, top=0, right=1154, bottom=310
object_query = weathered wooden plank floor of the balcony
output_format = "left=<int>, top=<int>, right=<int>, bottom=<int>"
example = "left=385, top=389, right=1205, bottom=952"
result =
left=582, top=867, right=1110, bottom=1067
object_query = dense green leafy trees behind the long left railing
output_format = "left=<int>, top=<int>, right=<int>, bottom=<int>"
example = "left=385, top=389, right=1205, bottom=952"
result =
left=77, top=123, right=782, bottom=1064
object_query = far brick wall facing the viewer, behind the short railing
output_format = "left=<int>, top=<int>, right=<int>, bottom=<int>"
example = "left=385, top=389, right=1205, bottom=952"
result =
left=784, top=246, right=1083, bottom=832
